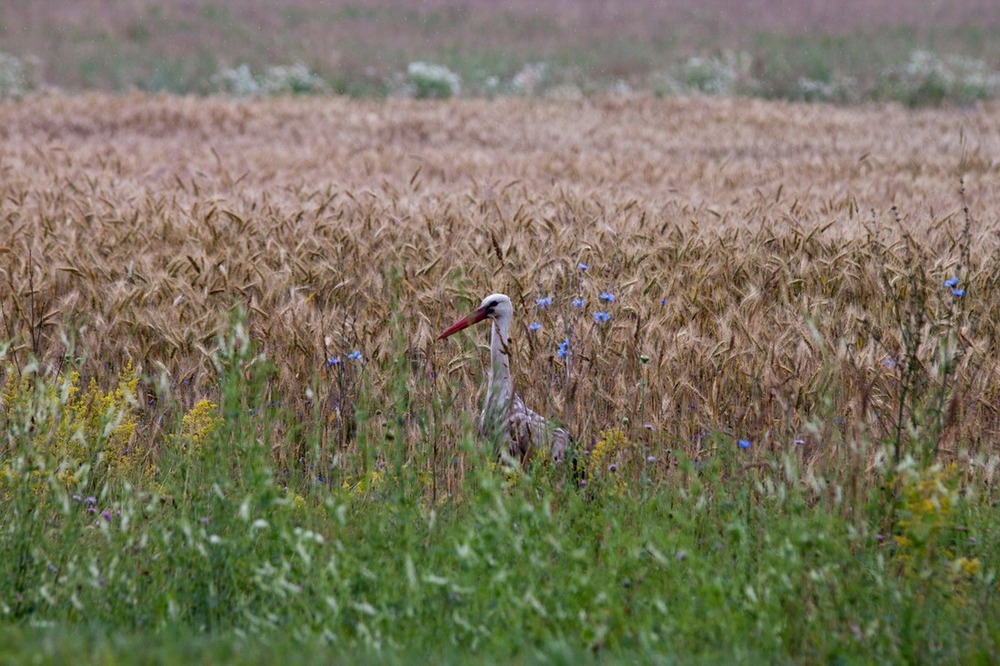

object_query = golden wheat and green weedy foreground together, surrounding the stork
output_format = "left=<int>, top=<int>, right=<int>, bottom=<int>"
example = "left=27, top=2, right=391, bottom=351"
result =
left=0, top=93, right=1000, bottom=663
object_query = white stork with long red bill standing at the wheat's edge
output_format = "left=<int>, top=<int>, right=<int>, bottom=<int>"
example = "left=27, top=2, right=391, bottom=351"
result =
left=437, top=294, right=570, bottom=462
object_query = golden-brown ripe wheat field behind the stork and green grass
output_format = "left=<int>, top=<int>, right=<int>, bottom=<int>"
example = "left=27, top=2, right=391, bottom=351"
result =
left=0, top=95, right=1000, bottom=478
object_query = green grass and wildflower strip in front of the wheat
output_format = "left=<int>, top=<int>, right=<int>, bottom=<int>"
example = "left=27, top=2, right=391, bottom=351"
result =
left=0, top=322, right=1000, bottom=663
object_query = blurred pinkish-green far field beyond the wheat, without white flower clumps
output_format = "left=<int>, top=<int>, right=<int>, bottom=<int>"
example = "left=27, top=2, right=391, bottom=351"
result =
left=0, top=0, right=1000, bottom=99
